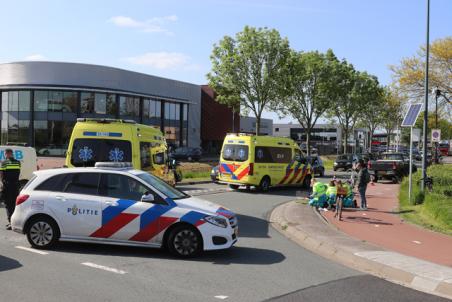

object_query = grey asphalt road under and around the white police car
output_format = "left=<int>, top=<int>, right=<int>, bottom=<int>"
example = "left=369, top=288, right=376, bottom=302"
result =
left=0, top=180, right=445, bottom=302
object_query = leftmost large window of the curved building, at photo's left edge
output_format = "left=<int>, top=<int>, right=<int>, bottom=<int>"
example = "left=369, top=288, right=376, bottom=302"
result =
left=1, top=90, right=31, bottom=144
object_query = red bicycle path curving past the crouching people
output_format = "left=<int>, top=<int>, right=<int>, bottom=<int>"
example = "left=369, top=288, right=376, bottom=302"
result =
left=320, top=183, right=452, bottom=267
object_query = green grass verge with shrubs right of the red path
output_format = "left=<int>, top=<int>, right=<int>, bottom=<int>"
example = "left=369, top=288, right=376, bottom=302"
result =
left=399, top=165, right=452, bottom=235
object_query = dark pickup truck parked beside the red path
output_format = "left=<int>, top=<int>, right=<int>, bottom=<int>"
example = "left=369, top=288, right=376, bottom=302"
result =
left=368, top=152, right=417, bottom=183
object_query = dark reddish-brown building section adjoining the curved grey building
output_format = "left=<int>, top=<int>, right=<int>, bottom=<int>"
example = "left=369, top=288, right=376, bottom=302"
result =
left=201, top=85, right=240, bottom=154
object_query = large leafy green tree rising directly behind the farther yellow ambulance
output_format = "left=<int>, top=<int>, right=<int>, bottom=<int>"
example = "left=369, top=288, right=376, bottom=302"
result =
left=207, top=26, right=291, bottom=135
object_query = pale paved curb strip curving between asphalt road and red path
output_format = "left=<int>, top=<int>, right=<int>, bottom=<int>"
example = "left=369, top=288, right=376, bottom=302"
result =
left=270, top=201, right=452, bottom=299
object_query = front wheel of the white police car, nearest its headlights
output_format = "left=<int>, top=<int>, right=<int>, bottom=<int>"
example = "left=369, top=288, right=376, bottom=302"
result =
left=168, top=225, right=202, bottom=258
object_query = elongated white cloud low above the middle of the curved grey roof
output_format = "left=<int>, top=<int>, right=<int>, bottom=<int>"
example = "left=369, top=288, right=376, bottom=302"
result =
left=124, top=51, right=191, bottom=69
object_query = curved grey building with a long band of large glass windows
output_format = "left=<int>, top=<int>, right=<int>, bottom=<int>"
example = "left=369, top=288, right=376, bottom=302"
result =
left=0, top=62, right=201, bottom=156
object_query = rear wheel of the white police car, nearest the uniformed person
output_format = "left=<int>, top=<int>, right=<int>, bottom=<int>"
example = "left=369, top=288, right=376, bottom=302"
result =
left=26, top=216, right=59, bottom=249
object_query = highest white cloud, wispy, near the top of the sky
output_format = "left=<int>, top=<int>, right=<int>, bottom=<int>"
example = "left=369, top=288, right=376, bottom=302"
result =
left=108, top=15, right=178, bottom=35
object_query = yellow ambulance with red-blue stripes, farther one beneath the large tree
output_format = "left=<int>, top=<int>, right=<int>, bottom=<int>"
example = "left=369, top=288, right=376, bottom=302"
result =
left=219, top=133, right=311, bottom=191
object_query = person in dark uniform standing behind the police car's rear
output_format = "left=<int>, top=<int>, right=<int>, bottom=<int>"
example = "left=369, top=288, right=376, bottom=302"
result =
left=0, top=149, right=20, bottom=230
